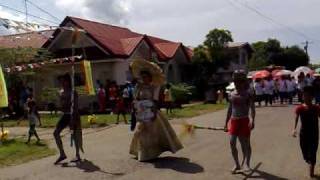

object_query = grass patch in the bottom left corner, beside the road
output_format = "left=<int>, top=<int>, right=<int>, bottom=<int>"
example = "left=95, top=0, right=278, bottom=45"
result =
left=0, top=139, right=56, bottom=168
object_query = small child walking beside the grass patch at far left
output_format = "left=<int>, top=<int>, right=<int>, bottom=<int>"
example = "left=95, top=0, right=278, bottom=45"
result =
left=27, top=100, right=41, bottom=144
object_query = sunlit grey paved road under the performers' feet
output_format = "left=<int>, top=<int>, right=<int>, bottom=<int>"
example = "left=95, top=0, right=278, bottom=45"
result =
left=0, top=106, right=316, bottom=180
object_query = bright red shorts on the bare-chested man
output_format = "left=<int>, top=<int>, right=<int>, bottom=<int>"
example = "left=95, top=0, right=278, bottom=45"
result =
left=228, top=117, right=251, bottom=137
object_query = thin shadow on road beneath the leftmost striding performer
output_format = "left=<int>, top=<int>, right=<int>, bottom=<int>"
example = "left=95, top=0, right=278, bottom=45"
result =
left=61, top=159, right=124, bottom=176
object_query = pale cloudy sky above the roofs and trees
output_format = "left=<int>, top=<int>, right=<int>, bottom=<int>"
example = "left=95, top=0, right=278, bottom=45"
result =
left=0, top=0, right=320, bottom=63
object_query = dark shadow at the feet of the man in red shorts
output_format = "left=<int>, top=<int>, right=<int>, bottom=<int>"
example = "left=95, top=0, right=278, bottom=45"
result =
left=240, top=162, right=288, bottom=180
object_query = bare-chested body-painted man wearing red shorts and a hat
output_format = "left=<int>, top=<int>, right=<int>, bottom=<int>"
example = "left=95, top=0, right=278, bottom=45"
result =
left=225, top=71, right=255, bottom=173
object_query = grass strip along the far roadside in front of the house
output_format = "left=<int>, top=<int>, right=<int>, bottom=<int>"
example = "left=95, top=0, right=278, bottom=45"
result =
left=0, top=103, right=226, bottom=128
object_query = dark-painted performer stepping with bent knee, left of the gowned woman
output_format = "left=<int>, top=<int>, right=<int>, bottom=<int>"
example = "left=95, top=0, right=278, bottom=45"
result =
left=53, top=74, right=82, bottom=164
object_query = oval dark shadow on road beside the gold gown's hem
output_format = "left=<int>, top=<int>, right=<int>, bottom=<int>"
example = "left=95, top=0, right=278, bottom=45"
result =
left=150, top=157, right=204, bottom=174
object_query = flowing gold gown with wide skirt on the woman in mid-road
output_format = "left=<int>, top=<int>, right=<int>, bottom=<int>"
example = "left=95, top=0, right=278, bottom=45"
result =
left=130, top=85, right=183, bottom=161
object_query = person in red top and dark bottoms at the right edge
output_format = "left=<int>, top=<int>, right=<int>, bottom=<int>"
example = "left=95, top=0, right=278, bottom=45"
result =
left=293, top=86, right=320, bottom=177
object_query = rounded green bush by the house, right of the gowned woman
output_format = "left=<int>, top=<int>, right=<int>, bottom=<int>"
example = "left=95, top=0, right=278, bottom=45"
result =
left=171, top=83, right=195, bottom=103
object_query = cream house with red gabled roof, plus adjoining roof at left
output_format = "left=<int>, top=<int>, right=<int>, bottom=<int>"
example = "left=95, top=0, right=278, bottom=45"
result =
left=0, top=17, right=192, bottom=107
